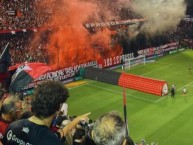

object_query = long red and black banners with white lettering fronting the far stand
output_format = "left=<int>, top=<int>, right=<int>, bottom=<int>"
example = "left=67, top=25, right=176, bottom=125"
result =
left=25, top=42, right=179, bottom=89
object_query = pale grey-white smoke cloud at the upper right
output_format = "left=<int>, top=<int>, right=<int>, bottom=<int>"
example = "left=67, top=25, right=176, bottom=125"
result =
left=132, top=0, right=186, bottom=34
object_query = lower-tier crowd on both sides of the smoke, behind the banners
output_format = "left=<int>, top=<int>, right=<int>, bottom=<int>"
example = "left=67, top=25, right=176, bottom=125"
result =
left=0, top=19, right=193, bottom=65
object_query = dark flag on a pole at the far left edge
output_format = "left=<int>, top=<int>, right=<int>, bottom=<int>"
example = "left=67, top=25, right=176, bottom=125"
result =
left=0, top=43, right=11, bottom=73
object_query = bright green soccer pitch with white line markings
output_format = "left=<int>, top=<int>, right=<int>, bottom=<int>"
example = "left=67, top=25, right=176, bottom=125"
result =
left=67, top=49, right=193, bottom=145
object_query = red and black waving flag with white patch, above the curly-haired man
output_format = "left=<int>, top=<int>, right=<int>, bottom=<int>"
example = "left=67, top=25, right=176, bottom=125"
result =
left=9, top=62, right=51, bottom=92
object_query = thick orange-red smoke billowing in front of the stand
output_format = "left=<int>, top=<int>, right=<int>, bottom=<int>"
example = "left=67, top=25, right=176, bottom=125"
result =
left=36, top=0, right=122, bottom=68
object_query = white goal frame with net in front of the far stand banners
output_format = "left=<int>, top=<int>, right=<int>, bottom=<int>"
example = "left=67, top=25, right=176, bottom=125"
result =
left=124, top=55, right=146, bottom=69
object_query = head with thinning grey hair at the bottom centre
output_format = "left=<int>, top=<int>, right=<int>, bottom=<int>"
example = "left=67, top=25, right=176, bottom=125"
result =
left=92, top=112, right=126, bottom=145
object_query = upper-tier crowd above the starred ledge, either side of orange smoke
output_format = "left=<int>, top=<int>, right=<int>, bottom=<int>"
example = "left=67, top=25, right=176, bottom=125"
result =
left=0, top=0, right=141, bottom=31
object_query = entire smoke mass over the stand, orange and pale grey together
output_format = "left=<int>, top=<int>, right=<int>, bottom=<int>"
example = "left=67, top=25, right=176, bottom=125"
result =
left=36, top=0, right=186, bottom=68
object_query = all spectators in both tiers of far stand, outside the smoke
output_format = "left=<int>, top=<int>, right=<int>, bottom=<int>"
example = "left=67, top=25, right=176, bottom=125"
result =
left=0, top=0, right=193, bottom=65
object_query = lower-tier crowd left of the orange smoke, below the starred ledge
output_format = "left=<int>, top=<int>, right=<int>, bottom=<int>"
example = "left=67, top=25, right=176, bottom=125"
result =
left=0, top=32, right=48, bottom=65
